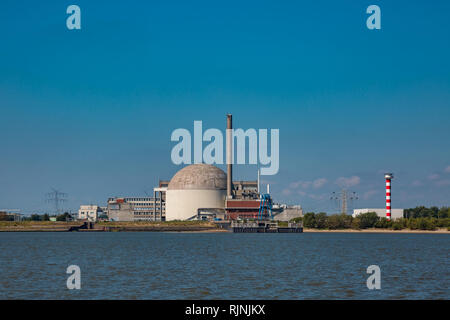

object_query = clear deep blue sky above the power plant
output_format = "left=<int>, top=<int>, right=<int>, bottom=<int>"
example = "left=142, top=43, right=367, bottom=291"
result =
left=0, top=0, right=450, bottom=212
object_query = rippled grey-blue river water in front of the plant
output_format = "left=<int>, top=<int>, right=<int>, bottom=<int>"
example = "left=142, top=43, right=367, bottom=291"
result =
left=0, top=232, right=450, bottom=299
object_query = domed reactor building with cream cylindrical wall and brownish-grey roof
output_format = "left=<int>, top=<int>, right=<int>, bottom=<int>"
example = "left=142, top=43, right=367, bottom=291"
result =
left=166, top=164, right=227, bottom=221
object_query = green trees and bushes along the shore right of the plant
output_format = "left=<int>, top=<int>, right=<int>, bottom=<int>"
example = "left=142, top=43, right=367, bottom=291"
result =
left=293, top=206, right=450, bottom=231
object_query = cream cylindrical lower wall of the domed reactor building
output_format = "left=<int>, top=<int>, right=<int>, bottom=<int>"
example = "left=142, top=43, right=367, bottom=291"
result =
left=166, top=190, right=227, bottom=221
